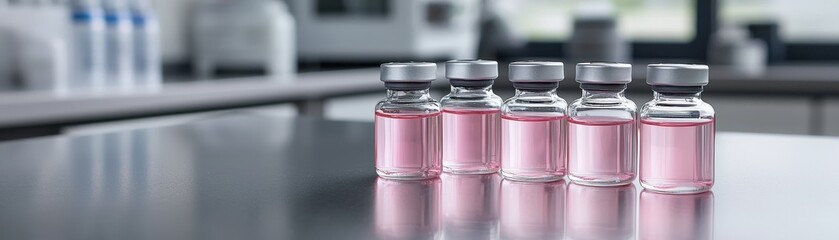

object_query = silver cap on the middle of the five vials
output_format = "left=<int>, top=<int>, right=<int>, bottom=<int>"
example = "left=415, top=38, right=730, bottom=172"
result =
left=510, top=61, right=565, bottom=82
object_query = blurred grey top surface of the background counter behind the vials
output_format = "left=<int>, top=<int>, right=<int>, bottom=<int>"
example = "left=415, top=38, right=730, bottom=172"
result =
left=0, top=64, right=839, bottom=130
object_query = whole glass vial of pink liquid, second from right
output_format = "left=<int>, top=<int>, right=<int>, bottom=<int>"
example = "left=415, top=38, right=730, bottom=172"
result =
left=568, top=63, right=637, bottom=186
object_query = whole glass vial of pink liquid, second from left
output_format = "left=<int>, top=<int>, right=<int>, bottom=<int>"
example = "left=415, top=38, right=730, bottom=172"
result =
left=440, top=60, right=502, bottom=174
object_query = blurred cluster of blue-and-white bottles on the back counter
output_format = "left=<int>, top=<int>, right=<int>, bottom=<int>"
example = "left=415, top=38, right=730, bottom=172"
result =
left=66, top=0, right=162, bottom=92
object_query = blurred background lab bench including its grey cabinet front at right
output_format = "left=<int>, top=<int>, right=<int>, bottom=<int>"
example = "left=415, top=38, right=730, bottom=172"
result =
left=0, top=64, right=839, bottom=140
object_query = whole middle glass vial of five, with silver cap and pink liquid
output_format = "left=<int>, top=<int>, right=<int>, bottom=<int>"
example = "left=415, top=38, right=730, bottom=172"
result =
left=501, top=62, right=567, bottom=182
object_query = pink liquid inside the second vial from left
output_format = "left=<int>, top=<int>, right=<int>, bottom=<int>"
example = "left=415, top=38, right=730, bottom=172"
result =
left=443, top=109, right=501, bottom=173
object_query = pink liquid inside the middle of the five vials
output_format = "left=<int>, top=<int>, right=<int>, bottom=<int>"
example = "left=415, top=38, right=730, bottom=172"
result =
left=501, top=115, right=566, bottom=181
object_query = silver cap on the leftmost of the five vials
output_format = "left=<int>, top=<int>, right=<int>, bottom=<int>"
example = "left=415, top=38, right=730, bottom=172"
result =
left=380, top=62, right=437, bottom=82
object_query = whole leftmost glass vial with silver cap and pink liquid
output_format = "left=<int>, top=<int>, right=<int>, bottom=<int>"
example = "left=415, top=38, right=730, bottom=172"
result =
left=375, top=62, right=442, bottom=179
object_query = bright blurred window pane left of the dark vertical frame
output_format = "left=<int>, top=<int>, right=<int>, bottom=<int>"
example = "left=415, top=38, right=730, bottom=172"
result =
left=496, top=0, right=696, bottom=42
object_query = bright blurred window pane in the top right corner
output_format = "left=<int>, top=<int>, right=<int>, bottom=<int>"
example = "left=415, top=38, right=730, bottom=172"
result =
left=720, top=0, right=839, bottom=42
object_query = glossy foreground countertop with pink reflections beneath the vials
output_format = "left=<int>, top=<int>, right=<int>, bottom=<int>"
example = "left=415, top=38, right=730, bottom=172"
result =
left=0, top=114, right=839, bottom=239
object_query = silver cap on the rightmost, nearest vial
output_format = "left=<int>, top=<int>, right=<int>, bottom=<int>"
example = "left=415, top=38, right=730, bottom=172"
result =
left=647, top=63, right=708, bottom=87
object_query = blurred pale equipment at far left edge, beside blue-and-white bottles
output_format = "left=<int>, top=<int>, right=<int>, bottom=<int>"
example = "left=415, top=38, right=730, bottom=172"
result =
left=0, top=3, right=69, bottom=91
